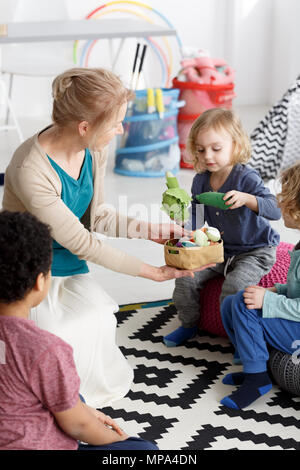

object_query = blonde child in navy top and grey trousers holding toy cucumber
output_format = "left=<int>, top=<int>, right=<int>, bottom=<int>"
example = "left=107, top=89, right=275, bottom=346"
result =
left=164, top=108, right=281, bottom=346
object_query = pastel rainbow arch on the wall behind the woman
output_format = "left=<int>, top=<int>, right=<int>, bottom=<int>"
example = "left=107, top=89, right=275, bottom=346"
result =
left=73, top=0, right=182, bottom=87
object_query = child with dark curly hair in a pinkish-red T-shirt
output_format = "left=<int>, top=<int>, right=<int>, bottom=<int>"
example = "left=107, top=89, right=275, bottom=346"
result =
left=0, top=211, right=157, bottom=450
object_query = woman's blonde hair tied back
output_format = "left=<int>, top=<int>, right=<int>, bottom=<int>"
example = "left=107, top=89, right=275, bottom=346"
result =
left=52, top=68, right=133, bottom=127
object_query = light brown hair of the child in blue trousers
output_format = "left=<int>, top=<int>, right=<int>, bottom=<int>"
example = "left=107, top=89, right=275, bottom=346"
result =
left=277, top=162, right=300, bottom=220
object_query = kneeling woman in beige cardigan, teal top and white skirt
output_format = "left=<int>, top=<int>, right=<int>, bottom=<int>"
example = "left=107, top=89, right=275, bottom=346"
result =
left=3, top=68, right=209, bottom=407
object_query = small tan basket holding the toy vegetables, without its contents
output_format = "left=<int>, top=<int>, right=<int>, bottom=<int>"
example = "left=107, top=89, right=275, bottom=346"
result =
left=164, top=239, right=224, bottom=269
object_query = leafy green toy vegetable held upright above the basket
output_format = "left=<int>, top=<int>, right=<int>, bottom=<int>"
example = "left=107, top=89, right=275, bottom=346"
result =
left=161, top=171, right=191, bottom=223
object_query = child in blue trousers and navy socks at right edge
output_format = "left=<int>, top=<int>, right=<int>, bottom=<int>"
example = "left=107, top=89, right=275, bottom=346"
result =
left=221, top=163, right=300, bottom=409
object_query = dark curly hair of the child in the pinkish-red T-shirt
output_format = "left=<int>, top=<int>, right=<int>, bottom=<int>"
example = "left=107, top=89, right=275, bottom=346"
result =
left=0, top=211, right=52, bottom=304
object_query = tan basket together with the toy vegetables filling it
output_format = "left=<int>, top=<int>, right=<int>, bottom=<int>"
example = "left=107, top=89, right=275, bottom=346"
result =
left=164, top=227, right=224, bottom=269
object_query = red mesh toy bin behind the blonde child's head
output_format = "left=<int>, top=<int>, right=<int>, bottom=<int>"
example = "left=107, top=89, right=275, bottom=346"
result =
left=173, top=78, right=236, bottom=168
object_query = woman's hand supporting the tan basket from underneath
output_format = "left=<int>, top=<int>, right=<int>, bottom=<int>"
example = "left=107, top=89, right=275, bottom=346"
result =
left=140, top=263, right=215, bottom=282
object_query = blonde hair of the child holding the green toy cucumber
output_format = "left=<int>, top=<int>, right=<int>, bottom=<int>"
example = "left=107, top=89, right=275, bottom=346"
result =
left=187, top=108, right=251, bottom=172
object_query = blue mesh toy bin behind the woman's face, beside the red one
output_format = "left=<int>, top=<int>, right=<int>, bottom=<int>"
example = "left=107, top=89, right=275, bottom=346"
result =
left=114, top=89, right=180, bottom=177
